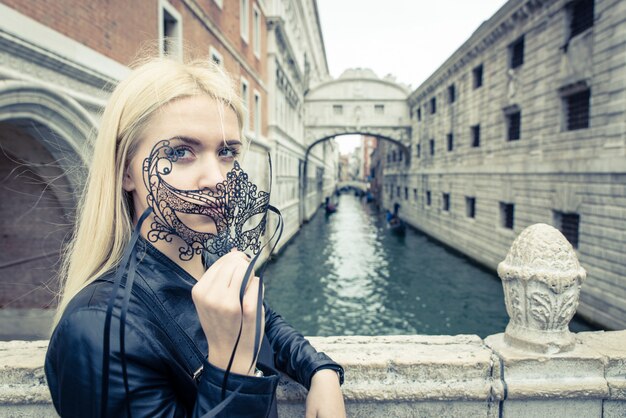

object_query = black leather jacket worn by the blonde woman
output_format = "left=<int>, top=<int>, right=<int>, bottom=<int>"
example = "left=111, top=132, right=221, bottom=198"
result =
left=45, top=239, right=343, bottom=418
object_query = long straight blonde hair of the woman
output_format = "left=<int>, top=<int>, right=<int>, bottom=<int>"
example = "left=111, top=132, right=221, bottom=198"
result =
left=54, top=58, right=245, bottom=325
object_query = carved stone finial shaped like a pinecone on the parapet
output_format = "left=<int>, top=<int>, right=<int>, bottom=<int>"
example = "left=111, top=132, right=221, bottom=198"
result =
left=498, top=224, right=587, bottom=354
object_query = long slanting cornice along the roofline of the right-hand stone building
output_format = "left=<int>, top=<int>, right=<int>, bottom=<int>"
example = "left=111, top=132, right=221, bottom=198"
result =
left=409, top=0, right=557, bottom=106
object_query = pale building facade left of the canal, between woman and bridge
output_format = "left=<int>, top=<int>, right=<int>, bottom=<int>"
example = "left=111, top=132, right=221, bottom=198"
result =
left=267, top=0, right=338, bottom=246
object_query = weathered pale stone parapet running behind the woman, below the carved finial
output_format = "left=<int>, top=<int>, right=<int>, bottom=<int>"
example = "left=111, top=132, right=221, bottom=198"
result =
left=0, top=331, right=626, bottom=418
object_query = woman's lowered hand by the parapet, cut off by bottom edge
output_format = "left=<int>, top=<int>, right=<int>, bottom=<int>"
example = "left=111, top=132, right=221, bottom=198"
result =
left=306, top=369, right=346, bottom=418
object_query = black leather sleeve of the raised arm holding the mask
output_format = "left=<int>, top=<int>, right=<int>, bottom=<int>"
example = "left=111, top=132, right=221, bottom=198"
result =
left=45, top=310, right=279, bottom=418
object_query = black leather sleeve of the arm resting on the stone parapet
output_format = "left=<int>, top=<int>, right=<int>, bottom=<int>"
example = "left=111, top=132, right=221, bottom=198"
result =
left=263, top=303, right=343, bottom=389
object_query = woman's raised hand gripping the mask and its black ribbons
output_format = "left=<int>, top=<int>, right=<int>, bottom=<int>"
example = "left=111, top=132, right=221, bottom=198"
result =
left=191, top=250, right=265, bottom=375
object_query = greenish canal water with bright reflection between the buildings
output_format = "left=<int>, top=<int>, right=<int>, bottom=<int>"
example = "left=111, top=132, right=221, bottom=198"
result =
left=265, top=194, right=594, bottom=337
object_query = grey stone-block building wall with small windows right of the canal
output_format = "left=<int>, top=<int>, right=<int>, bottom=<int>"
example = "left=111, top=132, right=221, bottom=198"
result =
left=384, top=0, right=626, bottom=329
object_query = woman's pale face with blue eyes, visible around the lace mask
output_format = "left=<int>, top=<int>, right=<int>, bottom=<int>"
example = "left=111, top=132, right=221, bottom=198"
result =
left=124, top=95, right=242, bottom=233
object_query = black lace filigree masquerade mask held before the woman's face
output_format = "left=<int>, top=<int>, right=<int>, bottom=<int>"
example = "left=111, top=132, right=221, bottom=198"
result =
left=143, top=140, right=271, bottom=260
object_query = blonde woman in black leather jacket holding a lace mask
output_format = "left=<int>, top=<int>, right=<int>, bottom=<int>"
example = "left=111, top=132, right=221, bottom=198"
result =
left=45, top=59, right=345, bottom=417
